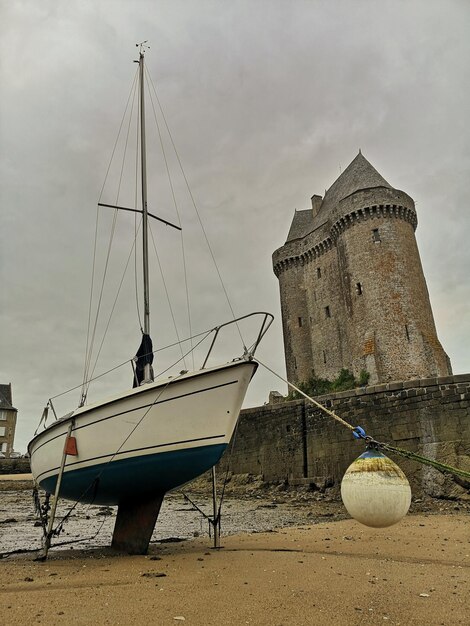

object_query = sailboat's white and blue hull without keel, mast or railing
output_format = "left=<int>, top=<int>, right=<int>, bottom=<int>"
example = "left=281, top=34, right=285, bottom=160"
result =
left=28, top=361, right=257, bottom=505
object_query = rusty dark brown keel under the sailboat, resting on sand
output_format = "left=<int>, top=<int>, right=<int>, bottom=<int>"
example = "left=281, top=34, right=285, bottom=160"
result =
left=111, top=494, right=165, bottom=554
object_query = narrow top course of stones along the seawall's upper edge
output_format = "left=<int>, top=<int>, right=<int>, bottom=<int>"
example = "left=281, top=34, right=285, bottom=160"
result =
left=243, top=373, right=470, bottom=413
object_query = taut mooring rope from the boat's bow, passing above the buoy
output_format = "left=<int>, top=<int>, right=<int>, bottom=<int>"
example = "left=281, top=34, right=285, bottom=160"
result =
left=254, top=358, right=470, bottom=481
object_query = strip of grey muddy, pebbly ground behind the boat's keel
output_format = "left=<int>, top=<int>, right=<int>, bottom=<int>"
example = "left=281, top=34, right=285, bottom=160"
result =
left=0, top=485, right=347, bottom=557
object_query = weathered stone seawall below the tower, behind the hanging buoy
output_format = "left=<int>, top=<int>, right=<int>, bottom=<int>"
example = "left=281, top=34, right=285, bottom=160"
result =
left=224, top=374, right=470, bottom=498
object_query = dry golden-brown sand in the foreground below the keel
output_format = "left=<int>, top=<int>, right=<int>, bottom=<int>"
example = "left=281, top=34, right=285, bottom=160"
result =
left=0, top=513, right=470, bottom=626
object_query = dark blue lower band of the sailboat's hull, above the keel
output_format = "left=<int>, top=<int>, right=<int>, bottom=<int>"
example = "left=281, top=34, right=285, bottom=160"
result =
left=40, top=444, right=227, bottom=505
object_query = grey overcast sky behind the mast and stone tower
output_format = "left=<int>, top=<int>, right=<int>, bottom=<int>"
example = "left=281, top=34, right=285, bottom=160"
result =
left=0, top=0, right=470, bottom=451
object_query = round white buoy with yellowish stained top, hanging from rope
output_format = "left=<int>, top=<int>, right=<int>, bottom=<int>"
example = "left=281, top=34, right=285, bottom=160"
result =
left=341, top=450, right=411, bottom=528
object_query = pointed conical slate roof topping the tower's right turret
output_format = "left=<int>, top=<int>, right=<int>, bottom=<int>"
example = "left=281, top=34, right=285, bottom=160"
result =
left=320, top=151, right=393, bottom=212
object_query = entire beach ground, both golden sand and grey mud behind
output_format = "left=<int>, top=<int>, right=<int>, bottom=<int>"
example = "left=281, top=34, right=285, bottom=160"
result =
left=0, top=477, right=470, bottom=626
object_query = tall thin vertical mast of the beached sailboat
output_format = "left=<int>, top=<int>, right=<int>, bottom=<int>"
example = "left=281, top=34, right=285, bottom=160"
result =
left=139, top=46, right=153, bottom=382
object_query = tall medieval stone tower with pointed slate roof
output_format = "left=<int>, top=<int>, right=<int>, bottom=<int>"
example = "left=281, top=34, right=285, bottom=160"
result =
left=273, top=152, right=451, bottom=384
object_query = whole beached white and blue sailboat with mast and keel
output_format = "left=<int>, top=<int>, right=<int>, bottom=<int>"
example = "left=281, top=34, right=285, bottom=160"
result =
left=28, top=46, right=273, bottom=553
